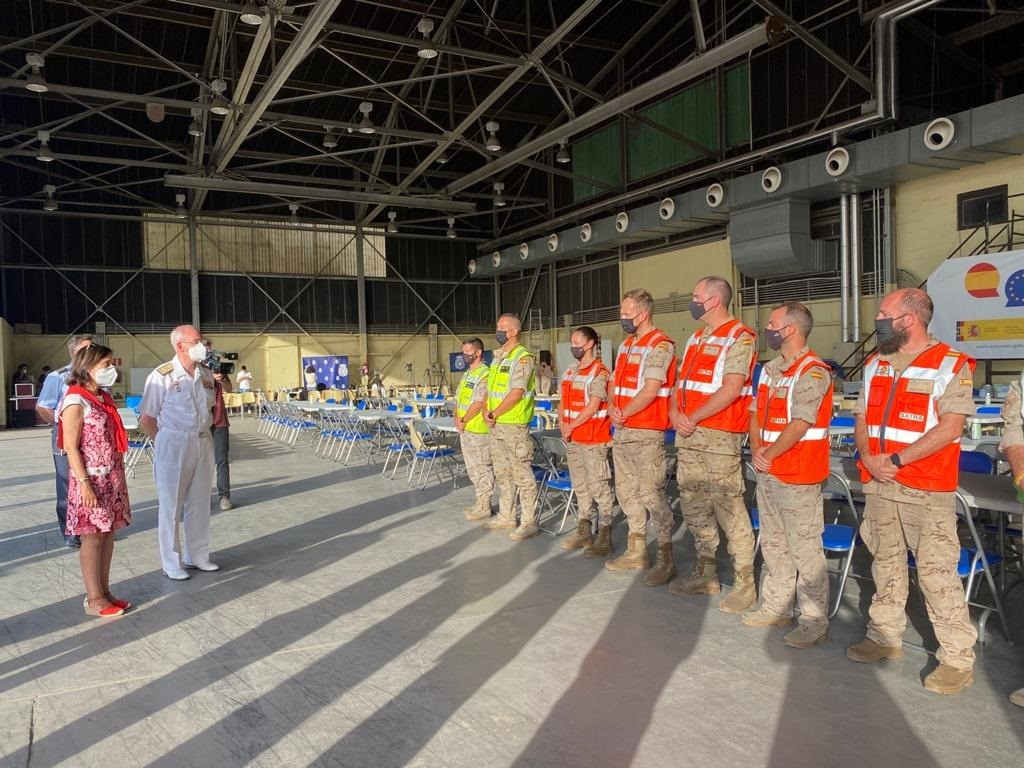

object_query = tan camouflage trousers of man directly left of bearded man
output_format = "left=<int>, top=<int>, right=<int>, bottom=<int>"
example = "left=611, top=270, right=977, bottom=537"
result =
left=758, top=473, right=828, bottom=629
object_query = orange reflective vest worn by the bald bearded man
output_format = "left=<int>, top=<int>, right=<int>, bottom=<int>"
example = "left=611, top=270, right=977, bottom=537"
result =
left=860, top=342, right=975, bottom=490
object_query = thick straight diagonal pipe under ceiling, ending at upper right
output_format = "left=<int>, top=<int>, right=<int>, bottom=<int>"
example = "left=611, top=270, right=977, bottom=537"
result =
left=447, top=16, right=785, bottom=194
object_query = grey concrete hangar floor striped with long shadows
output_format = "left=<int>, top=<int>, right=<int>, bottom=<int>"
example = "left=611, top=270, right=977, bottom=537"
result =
left=0, top=419, right=1024, bottom=768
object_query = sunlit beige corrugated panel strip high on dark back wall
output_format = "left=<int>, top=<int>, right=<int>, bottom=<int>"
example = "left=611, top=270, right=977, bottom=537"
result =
left=143, top=214, right=387, bottom=278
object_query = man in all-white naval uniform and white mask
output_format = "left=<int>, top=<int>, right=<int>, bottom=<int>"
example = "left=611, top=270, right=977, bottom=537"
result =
left=139, top=326, right=220, bottom=581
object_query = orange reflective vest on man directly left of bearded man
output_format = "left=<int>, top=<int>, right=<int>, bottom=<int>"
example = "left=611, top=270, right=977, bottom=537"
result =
left=758, top=351, right=833, bottom=485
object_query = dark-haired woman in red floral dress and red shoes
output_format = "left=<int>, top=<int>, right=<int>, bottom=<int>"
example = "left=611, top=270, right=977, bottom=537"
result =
left=57, top=344, right=131, bottom=617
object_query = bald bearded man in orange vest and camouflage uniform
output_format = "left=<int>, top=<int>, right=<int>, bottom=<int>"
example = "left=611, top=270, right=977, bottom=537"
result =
left=847, top=289, right=978, bottom=693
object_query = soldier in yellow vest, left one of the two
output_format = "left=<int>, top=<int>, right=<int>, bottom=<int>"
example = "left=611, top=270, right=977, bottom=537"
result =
left=455, top=338, right=495, bottom=520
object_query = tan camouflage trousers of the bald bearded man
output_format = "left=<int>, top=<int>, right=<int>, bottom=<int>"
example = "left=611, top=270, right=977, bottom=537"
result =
left=860, top=494, right=978, bottom=670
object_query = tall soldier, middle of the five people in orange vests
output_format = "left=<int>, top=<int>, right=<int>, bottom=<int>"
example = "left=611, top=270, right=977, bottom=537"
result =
left=669, top=276, right=757, bottom=613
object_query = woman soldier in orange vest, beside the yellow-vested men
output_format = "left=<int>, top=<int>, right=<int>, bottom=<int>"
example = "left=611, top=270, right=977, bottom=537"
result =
left=558, top=326, right=615, bottom=557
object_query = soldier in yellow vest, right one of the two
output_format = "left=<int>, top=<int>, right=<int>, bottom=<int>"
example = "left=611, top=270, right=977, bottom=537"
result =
left=483, top=314, right=540, bottom=541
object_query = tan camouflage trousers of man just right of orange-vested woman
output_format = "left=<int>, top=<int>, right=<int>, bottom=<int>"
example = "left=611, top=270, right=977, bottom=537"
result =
left=611, top=429, right=672, bottom=544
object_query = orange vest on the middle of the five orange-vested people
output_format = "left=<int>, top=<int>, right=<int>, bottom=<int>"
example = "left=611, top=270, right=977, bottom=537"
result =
left=676, top=317, right=757, bottom=432
